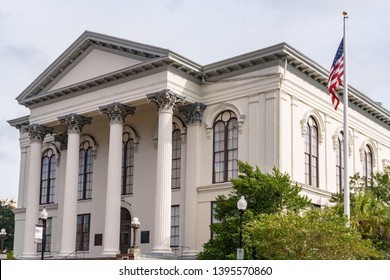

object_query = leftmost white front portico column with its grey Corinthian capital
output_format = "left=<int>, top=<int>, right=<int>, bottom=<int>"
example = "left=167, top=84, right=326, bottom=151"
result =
left=21, top=124, right=53, bottom=259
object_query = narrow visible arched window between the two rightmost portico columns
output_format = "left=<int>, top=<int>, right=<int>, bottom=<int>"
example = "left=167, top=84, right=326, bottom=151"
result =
left=172, top=127, right=181, bottom=189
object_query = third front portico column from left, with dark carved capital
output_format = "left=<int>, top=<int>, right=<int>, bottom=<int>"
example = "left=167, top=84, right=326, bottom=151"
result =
left=99, top=103, right=135, bottom=256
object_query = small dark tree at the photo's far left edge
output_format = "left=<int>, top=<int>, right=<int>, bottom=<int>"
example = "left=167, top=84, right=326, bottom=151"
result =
left=0, top=199, right=15, bottom=250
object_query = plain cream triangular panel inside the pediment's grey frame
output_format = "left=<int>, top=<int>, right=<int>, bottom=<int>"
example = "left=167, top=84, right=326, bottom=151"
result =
left=48, top=48, right=144, bottom=91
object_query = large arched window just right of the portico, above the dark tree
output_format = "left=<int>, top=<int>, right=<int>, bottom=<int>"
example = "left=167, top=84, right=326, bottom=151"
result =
left=213, top=110, right=238, bottom=183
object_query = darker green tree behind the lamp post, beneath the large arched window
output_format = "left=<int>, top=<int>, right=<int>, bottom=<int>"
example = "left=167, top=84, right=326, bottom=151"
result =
left=198, top=161, right=311, bottom=260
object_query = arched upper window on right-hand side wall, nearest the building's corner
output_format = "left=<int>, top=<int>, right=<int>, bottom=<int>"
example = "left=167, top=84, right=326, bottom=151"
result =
left=305, top=117, right=318, bottom=187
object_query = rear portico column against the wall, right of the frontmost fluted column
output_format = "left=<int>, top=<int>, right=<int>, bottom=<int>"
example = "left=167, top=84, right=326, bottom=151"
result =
left=179, top=102, right=206, bottom=259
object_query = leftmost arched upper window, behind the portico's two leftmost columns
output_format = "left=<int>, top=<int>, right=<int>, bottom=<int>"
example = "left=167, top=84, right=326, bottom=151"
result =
left=39, top=149, right=57, bottom=204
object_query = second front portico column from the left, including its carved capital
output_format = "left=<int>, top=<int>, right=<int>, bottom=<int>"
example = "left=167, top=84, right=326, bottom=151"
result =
left=58, top=114, right=91, bottom=257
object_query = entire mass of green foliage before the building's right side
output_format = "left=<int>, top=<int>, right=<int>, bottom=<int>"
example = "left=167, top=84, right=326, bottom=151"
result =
left=198, top=162, right=390, bottom=259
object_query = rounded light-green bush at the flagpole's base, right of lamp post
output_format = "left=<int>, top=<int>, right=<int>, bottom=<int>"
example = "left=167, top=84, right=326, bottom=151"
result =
left=244, top=209, right=383, bottom=260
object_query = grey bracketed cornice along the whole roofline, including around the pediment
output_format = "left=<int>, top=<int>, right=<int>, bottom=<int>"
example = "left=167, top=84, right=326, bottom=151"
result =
left=17, top=31, right=390, bottom=126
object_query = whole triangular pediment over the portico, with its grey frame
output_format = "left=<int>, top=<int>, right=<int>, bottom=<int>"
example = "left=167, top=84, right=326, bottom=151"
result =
left=16, top=31, right=170, bottom=107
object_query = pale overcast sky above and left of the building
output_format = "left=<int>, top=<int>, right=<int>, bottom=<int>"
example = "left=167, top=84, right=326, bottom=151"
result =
left=0, top=0, right=390, bottom=199
